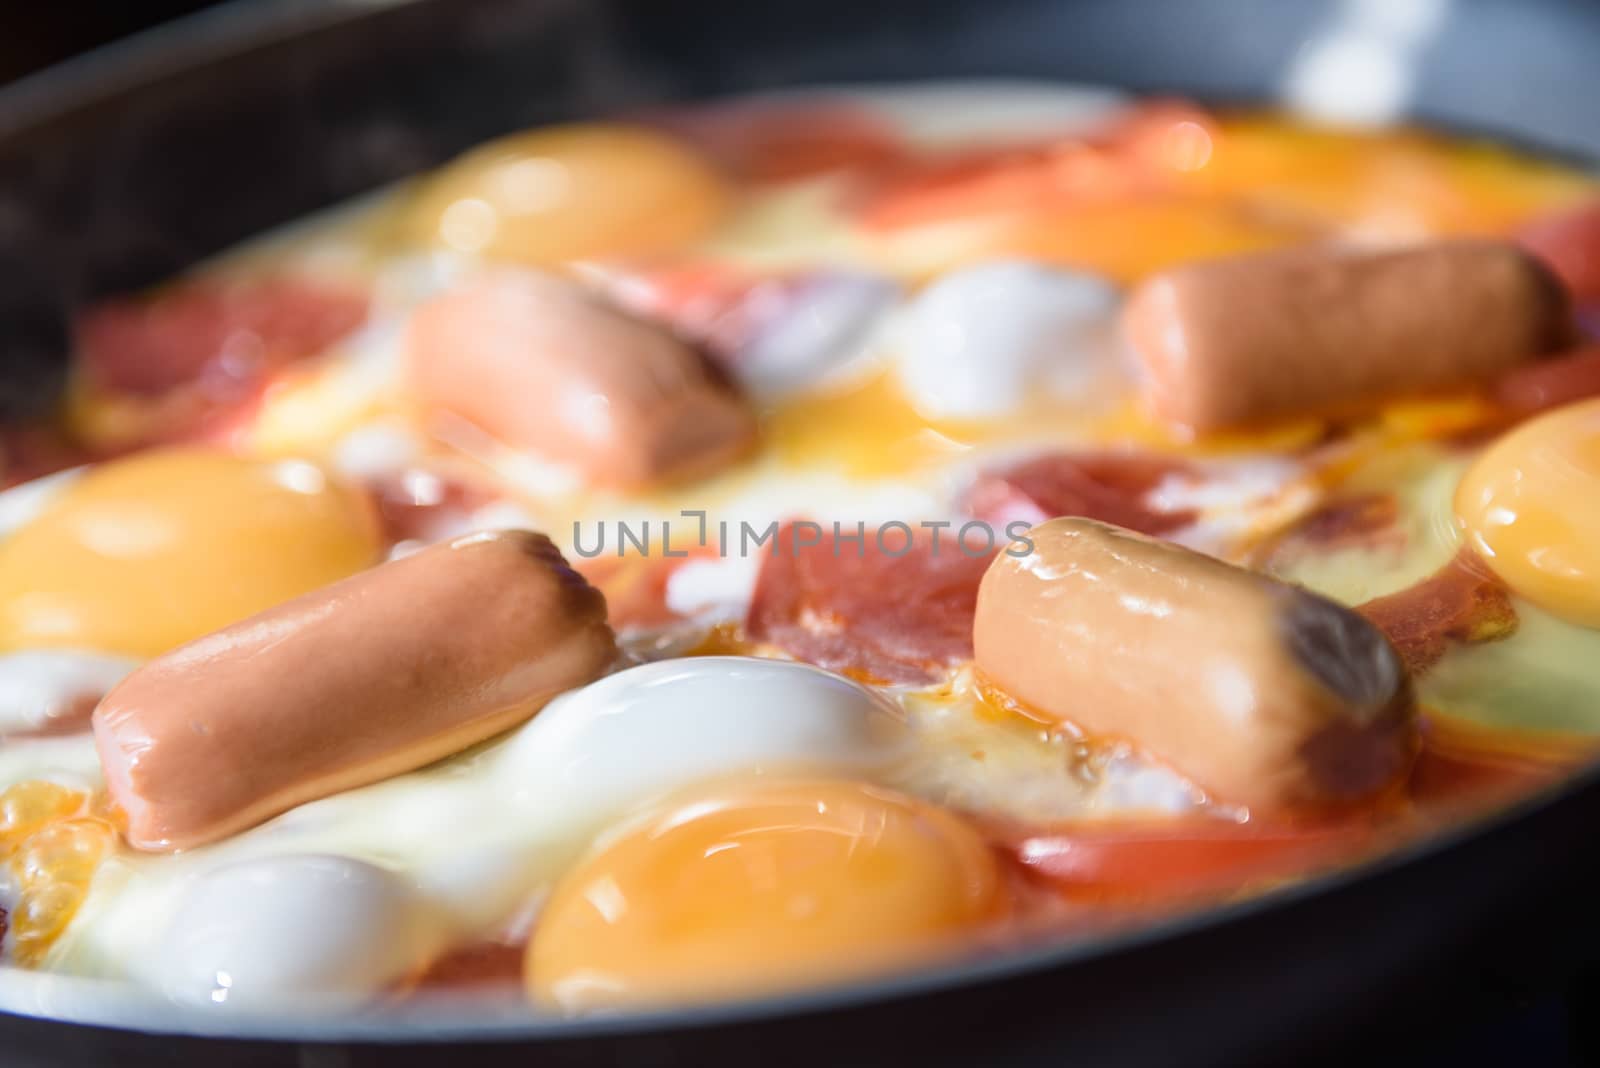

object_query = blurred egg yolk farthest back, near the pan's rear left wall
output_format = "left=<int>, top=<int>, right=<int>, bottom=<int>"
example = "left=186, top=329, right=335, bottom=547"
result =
left=410, top=123, right=730, bottom=264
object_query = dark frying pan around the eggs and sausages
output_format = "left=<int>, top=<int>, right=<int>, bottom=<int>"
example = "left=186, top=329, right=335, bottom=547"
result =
left=0, top=0, right=1600, bottom=1068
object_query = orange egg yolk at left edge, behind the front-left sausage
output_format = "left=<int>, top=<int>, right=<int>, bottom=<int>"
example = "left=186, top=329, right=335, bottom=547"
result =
left=0, top=449, right=379, bottom=656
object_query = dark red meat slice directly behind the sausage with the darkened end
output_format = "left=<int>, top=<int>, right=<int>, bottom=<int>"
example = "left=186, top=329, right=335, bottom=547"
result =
left=966, top=452, right=1197, bottom=536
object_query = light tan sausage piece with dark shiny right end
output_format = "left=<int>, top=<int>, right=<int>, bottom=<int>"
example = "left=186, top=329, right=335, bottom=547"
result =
left=973, top=516, right=1416, bottom=811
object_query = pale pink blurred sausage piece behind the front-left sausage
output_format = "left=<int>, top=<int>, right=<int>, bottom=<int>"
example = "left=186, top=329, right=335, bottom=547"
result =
left=410, top=270, right=755, bottom=489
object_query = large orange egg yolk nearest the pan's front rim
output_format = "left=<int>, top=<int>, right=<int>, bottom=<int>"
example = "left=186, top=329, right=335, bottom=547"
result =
left=526, top=780, right=1006, bottom=1012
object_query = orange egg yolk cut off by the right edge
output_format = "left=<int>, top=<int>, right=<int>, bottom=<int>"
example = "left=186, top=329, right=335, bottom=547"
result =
left=1456, top=400, right=1600, bottom=627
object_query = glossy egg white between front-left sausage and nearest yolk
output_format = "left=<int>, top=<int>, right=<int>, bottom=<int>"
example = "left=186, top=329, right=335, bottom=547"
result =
left=31, top=657, right=1203, bottom=1006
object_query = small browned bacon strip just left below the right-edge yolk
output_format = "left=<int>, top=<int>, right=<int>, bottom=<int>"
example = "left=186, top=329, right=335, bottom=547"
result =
left=1355, top=550, right=1517, bottom=675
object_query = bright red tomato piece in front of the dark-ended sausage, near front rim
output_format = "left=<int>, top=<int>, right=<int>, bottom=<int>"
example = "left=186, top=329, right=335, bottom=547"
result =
left=1006, top=817, right=1376, bottom=903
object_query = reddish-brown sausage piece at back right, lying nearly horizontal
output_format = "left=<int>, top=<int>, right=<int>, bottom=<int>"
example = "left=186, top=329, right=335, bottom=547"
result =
left=1123, top=241, right=1571, bottom=432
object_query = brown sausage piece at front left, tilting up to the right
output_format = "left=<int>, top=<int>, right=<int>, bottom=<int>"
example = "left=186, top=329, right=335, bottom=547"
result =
left=93, top=531, right=616, bottom=851
